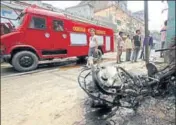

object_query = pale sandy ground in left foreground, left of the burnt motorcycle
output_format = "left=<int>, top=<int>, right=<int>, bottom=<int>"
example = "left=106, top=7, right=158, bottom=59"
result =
left=1, top=66, right=88, bottom=125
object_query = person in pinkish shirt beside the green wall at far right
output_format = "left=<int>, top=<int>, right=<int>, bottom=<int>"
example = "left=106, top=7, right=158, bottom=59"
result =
left=160, top=20, right=167, bottom=57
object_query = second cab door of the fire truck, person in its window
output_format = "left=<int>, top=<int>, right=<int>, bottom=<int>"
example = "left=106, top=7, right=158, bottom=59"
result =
left=51, top=19, right=69, bottom=55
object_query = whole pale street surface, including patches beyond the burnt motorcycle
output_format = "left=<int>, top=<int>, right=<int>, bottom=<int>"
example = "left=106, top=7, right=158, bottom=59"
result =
left=1, top=53, right=175, bottom=125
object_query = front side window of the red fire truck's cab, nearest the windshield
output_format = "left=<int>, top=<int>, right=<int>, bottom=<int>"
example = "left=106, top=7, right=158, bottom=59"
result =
left=29, top=17, right=46, bottom=30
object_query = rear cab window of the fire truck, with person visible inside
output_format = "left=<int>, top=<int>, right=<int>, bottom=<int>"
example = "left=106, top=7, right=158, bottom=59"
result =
left=53, top=20, right=64, bottom=32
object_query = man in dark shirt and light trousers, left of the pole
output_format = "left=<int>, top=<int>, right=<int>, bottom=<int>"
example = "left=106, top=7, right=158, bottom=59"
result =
left=132, top=30, right=142, bottom=62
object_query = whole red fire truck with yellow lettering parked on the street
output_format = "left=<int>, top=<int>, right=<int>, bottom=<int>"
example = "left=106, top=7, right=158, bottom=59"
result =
left=1, top=6, right=114, bottom=71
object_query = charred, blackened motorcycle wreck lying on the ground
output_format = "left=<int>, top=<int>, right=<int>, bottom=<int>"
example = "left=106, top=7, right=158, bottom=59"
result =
left=78, top=49, right=176, bottom=110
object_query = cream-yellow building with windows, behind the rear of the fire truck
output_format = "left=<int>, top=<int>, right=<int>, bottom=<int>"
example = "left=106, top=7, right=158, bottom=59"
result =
left=94, top=5, right=144, bottom=35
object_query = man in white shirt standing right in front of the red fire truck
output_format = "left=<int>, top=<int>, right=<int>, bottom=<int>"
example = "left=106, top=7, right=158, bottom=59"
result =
left=87, top=28, right=98, bottom=66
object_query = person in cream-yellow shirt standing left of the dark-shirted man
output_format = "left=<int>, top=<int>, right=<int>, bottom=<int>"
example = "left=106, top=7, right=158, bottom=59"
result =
left=125, top=35, right=132, bottom=61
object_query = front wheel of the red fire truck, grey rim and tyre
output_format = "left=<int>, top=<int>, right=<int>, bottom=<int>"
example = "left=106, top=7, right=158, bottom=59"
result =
left=12, top=51, right=38, bottom=72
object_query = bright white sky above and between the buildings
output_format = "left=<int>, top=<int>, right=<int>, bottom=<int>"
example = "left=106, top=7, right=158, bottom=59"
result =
left=42, top=1, right=167, bottom=31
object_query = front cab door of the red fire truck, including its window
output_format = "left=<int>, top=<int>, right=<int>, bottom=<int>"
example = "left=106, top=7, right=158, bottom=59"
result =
left=25, top=15, right=52, bottom=51
